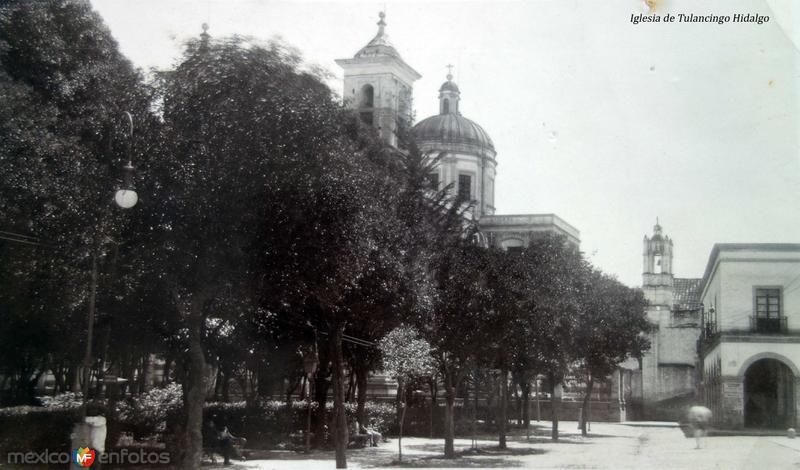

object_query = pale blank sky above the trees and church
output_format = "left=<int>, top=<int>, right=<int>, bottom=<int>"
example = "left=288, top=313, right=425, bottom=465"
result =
left=92, top=0, right=800, bottom=286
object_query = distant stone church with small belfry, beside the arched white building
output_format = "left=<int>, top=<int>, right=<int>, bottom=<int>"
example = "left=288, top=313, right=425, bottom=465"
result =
left=636, top=221, right=702, bottom=412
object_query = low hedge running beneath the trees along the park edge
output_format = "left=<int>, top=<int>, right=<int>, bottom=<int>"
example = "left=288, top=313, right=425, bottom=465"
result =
left=0, top=392, right=396, bottom=454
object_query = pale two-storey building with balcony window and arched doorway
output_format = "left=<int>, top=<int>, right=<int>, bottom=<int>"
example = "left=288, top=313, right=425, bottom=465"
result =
left=699, top=243, right=800, bottom=429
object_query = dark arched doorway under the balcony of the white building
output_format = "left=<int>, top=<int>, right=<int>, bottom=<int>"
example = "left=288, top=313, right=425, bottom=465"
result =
left=744, top=359, right=794, bottom=429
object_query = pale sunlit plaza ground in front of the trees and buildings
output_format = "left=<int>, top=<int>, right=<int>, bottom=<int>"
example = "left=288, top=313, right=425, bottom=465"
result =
left=211, top=421, right=800, bottom=470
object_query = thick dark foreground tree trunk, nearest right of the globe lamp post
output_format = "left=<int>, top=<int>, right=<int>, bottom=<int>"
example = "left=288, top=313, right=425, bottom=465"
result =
left=182, top=294, right=206, bottom=469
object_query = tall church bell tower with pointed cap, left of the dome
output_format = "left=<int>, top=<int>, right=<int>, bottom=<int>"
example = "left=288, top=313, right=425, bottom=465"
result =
left=336, top=12, right=422, bottom=146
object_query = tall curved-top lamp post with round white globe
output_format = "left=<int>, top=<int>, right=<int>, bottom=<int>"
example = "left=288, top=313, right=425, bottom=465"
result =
left=81, top=111, right=139, bottom=421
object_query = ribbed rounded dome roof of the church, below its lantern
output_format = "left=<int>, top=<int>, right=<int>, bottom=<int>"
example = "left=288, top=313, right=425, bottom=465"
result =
left=412, top=113, right=494, bottom=151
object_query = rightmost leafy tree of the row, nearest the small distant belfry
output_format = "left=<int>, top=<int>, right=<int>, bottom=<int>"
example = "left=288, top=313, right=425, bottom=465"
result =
left=574, top=269, right=650, bottom=435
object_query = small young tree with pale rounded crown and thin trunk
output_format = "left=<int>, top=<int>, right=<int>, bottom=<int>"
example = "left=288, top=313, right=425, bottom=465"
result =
left=378, top=326, right=434, bottom=462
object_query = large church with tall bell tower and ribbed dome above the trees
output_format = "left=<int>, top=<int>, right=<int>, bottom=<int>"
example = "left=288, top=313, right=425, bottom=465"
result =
left=336, top=12, right=580, bottom=250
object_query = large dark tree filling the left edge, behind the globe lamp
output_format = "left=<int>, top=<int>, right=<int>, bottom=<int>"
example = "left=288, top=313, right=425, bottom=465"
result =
left=0, top=0, right=155, bottom=402
